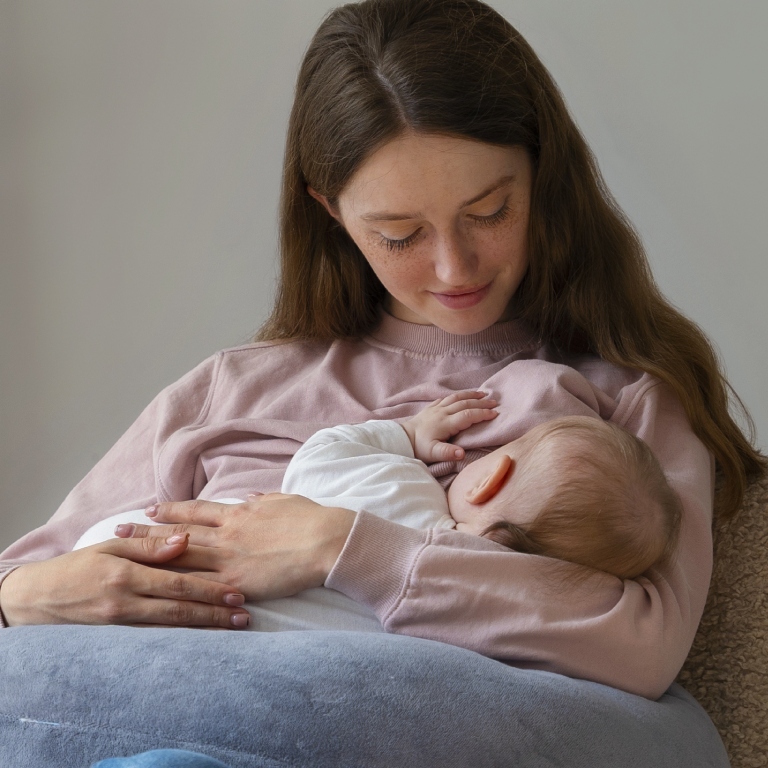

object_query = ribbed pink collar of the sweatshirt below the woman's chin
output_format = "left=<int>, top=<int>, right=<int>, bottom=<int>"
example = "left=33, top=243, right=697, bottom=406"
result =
left=367, top=312, right=534, bottom=356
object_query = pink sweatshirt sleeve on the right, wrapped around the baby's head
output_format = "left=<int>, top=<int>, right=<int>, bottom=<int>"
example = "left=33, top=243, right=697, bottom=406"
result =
left=326, top=379, right=714, bottom=699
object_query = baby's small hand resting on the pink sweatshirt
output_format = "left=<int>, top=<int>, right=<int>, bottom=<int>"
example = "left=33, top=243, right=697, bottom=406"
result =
left=402, top=392, right=499, bottom=463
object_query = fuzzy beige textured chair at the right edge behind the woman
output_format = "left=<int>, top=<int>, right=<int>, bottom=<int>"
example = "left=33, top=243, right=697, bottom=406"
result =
left=677, top=479, right=768, bottom=768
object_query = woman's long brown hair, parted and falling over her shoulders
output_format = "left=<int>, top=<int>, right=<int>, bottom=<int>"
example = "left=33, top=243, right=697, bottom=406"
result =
left=256, top=0, right=766, bottom=518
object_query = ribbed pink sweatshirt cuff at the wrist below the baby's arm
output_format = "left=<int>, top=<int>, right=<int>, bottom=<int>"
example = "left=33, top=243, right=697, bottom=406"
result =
left=325, top=512, right=432, bottom=624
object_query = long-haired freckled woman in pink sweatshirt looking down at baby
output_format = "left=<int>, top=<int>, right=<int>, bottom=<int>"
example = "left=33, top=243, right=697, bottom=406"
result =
left=0, top=0, right=764, bottom=760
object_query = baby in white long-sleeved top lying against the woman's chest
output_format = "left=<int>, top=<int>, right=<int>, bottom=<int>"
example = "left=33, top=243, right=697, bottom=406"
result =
left=282, top=392, right=681, bottom=579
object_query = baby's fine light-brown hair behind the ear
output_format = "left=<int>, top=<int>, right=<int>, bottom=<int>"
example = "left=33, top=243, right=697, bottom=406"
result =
left=482, top=416, right=682, bottom=579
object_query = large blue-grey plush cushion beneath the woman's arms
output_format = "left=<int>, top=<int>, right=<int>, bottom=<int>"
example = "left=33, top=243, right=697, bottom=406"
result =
left=0, top=626, right=728, bottom=768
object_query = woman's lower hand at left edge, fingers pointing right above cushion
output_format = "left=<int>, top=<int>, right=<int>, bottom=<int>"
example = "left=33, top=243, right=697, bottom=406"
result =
left=0, top=535, right=250, bottom=629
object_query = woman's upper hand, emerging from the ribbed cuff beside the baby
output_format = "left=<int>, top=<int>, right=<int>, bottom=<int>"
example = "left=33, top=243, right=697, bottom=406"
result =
left=116, top=493, right=355, bottom=600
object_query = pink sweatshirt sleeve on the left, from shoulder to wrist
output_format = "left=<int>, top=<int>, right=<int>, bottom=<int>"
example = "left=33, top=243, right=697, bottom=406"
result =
left=0, top=356, right=219, bottom=626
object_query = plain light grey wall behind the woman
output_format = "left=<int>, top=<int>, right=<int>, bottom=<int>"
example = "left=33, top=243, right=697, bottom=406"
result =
left=0, top=0, right=768, bottom=549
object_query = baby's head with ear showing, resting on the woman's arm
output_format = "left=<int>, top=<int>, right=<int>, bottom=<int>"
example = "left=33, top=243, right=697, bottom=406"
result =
left=448, top=416, right=682, bottom=579
